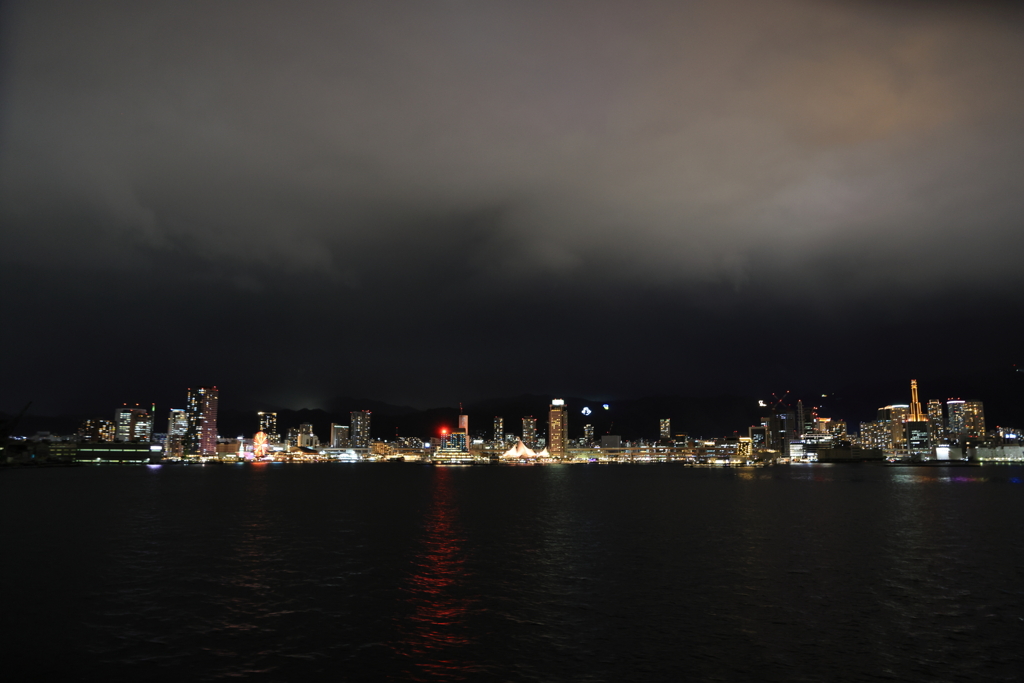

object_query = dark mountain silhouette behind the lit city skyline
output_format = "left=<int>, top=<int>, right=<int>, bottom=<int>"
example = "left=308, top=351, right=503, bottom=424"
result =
left=9, top=368, right=1024, bottom=441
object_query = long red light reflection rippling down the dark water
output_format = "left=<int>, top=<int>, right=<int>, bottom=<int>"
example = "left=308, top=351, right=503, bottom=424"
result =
left=396, top=467, right=476, bottom=680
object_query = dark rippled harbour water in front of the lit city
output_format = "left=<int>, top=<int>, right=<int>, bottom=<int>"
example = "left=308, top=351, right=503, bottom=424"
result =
left=0, top=465, right=1024, bottom=681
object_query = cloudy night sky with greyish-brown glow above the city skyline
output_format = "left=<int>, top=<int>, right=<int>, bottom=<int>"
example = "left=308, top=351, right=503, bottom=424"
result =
left=0, top=0, right=1024, bottom=415
